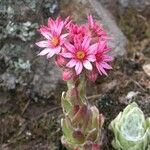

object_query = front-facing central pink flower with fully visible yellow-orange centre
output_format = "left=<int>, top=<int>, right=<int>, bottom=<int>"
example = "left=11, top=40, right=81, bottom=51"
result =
left=61, top=37, right=95, bottom=75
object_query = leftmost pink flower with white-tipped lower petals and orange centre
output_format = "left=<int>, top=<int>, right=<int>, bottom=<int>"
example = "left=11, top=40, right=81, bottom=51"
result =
left=36, top=17, right=67, bottom=58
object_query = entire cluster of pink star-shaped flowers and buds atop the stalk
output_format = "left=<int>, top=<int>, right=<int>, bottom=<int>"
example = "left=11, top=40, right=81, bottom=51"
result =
left=36, top=15, right=113, bottom=81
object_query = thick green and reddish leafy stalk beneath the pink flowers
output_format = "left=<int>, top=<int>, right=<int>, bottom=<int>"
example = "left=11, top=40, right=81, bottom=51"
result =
left=61, top=77, right=104, bottom=150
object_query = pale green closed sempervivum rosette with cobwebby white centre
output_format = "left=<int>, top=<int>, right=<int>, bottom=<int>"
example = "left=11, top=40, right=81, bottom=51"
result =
left=109, top=102, right=150, bottom=150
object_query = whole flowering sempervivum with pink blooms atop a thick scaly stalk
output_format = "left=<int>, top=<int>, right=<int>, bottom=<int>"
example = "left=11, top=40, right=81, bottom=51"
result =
left=36, top=15, right=112, bottom=150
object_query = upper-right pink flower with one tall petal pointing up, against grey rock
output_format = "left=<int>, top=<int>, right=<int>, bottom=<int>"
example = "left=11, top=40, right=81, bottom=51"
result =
left=88, top=15, right=108, bottom=39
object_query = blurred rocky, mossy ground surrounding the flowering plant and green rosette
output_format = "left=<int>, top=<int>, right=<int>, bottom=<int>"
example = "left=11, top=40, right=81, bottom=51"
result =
left=0, top=0, right=150, bottom=150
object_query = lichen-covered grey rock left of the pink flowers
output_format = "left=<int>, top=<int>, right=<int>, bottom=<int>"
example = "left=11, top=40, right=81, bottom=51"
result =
left=0, top=0, right=61, bottom=100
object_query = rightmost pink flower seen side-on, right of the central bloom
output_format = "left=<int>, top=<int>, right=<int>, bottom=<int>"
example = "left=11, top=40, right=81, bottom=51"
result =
left=95, top=41, right=113, bottom=76
